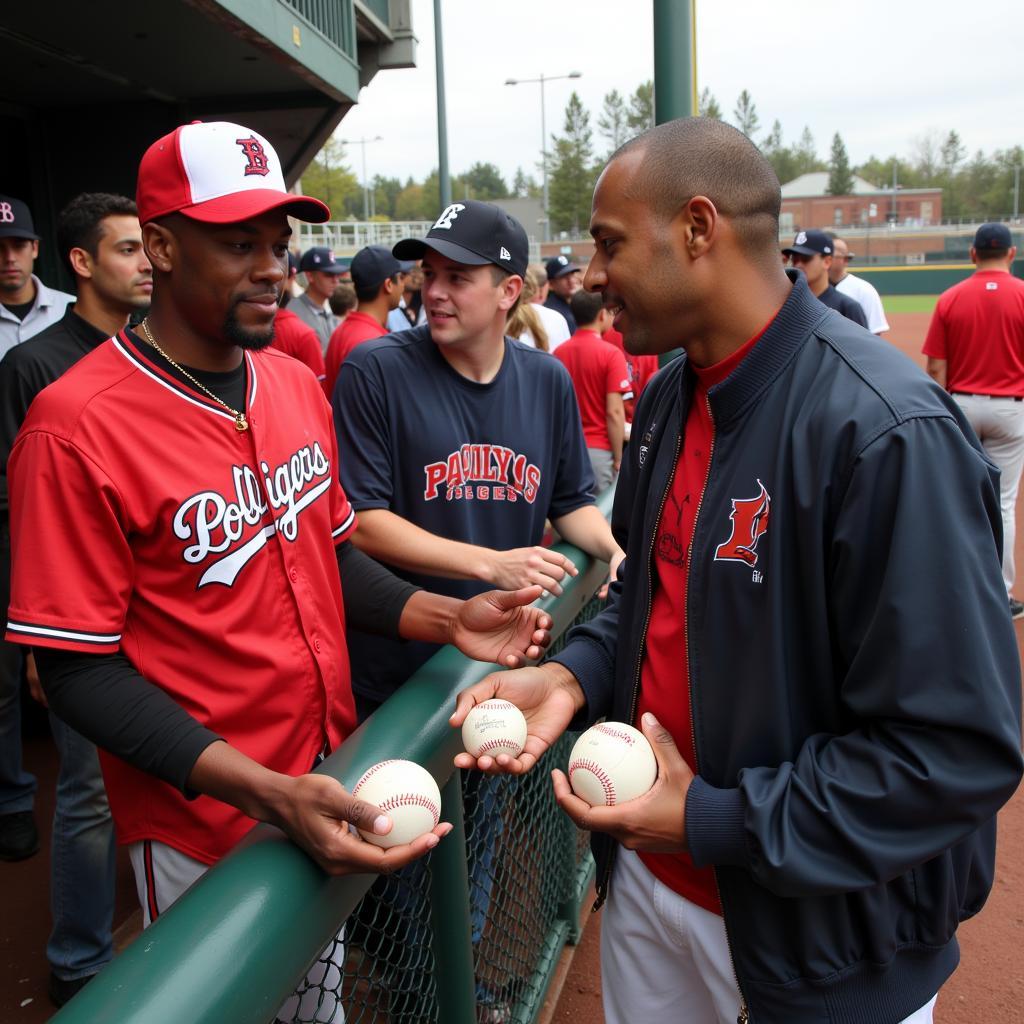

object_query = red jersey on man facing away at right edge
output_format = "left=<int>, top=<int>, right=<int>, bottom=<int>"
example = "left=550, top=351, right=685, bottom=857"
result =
left=924, top=270, right=1024, bottom=398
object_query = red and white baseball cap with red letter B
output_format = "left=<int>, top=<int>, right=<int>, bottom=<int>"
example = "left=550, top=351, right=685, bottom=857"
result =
left=135, top=121, right=331, bottom=224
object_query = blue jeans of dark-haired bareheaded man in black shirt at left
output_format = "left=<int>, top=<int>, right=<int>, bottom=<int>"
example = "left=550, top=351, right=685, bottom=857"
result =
left=46, top=714, right=117, bottom=980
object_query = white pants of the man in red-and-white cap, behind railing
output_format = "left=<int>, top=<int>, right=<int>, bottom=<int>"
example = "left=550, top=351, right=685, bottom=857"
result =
left=128, top=840, right=345, bottom=1024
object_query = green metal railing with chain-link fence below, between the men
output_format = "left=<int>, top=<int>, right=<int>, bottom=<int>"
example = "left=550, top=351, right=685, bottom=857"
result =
left=54, top=490, right=612, bottom=1024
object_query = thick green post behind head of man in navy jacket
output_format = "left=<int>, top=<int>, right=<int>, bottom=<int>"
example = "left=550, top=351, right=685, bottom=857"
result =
left=654, top=0, right=697, bottom=367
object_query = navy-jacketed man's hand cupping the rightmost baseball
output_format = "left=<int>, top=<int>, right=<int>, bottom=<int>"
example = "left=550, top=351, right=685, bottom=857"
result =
left=551, top=712, right=693, bottom=853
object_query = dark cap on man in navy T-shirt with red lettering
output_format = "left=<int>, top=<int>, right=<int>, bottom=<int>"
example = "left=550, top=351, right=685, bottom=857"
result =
left=391, top=199, right=529, bottom=278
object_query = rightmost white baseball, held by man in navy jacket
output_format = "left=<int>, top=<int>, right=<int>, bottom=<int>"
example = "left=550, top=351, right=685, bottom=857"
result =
left=569, top=722, right=657, bottom=807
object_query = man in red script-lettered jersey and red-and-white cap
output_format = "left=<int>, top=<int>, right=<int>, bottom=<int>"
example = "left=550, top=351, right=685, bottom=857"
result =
left=7, top=122, right=550, bottom=1020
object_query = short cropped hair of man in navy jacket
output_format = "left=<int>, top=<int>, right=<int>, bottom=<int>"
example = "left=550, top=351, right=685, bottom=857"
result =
left=609, top=118, right=782, bottom=261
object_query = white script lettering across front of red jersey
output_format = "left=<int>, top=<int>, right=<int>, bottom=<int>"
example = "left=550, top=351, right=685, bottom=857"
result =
left=174, top=441, right=332, bottom=587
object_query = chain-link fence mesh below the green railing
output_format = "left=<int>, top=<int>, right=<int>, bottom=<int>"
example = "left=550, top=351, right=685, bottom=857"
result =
left=278, top=598, right=603, bottom=1024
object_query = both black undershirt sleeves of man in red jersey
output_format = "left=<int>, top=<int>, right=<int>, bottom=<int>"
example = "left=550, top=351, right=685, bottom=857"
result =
left=35, top=541, right=418, bottom=798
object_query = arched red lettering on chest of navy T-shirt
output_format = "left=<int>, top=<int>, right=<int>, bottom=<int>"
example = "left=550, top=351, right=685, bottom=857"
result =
left=423, top=444, right=541, bottom=505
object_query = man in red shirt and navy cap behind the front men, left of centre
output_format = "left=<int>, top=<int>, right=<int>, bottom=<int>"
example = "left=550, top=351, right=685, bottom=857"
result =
left=324, top=246, right=416, bottom=398
